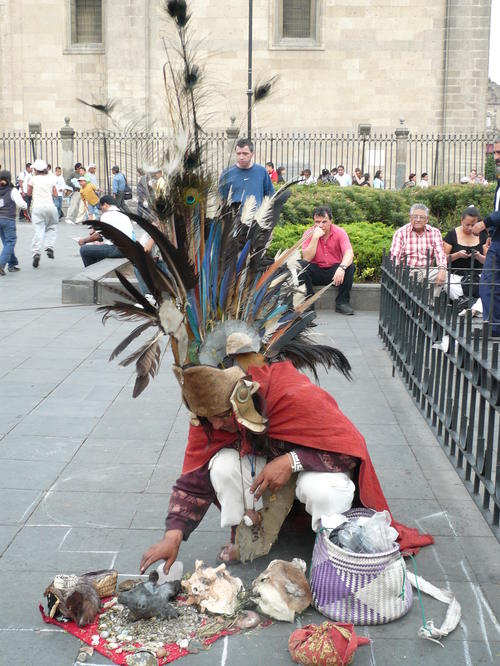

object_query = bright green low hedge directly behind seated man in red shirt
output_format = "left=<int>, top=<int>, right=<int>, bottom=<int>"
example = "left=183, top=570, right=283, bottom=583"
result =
left=269, top=222, right=394, bottom=282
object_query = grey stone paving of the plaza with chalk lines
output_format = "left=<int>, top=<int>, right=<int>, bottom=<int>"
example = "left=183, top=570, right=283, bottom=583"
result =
left=0, top=223, right=500, bottom=666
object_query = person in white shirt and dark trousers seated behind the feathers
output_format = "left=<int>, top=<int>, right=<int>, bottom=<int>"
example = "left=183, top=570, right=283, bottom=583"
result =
left=78, top=195, right=135, bottom=267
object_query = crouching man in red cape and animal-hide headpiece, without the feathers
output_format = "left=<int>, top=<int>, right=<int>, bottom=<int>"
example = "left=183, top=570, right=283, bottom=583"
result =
left=140, top=336, right=433, bottom=573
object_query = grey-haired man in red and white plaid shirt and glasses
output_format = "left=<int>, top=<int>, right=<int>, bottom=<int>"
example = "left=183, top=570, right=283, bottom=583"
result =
left=391, top=204, right=447, bottom=295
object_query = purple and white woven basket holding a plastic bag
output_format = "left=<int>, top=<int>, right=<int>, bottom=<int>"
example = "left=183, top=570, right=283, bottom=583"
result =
left=310, top=508, right=413, bottom=625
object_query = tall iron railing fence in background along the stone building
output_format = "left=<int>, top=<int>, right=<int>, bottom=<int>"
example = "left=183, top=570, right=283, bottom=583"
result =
left=0, top=127, right=493, bottom=189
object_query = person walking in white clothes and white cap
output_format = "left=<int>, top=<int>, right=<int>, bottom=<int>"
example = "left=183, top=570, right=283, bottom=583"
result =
left=28, top=159, right=58, bottom=268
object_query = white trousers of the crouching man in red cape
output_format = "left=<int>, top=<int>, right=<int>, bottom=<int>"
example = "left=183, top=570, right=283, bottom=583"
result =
left=209, top=449, right=355, bottom=532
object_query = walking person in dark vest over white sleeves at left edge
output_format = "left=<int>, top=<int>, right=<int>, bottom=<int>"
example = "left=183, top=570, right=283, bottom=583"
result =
left=0, top=170, right=28, bottom=275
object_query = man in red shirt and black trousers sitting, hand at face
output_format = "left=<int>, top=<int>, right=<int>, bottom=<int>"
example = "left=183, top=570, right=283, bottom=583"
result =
left=299, top=206, right=354, bottom=315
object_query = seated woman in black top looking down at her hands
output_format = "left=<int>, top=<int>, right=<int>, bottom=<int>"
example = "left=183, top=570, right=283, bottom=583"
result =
left=444, top=206, right=487, bottom=298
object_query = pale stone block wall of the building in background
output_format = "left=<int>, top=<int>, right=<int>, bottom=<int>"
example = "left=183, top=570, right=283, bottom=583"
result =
left=0, top=0, right=490, bottom=132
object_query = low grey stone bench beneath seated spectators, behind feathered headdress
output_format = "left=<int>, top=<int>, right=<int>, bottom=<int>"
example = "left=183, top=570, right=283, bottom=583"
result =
left=62, top=259, right=380, bottom=312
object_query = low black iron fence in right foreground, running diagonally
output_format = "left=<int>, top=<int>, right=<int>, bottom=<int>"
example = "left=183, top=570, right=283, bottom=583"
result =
left=379, top=257, right=500, bottom=538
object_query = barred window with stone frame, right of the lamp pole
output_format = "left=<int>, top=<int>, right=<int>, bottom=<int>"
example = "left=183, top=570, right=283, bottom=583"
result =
left=272, top=0, right=322, bottom=49
